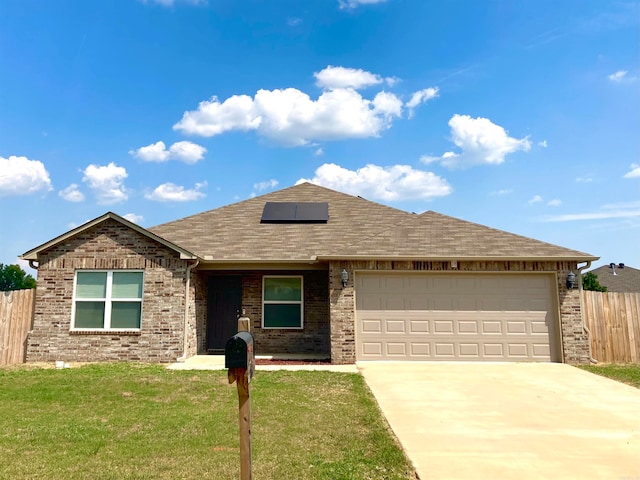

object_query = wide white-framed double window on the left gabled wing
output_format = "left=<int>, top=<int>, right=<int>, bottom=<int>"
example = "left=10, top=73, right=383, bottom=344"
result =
left=73, top=270, right=143, bottom=330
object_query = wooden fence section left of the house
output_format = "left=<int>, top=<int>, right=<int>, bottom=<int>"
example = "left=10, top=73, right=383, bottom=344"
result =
left=0, top=288, right=36, bottom=365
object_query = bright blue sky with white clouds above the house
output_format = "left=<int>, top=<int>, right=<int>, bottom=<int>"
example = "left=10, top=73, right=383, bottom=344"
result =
left=0, top=0, right=640, bottom=274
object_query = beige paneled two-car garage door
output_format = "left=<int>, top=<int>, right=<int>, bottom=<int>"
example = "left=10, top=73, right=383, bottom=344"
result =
left=355, top=272, right=559, bottom=362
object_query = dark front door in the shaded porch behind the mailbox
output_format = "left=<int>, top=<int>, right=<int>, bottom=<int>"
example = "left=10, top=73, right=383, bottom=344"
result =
left=207, top=275, right=242, bottom=351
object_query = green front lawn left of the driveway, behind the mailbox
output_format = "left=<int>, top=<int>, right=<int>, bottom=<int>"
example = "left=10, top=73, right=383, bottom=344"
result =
left=0, top=364, right=415, bottom=480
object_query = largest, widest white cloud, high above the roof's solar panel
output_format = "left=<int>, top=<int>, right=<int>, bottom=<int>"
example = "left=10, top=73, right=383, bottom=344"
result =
left=173, top=88, right=402, bottom=146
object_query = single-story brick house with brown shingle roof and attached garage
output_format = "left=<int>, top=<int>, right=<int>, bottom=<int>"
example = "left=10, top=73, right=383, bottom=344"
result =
left=22, top=183, right=597, bottom=364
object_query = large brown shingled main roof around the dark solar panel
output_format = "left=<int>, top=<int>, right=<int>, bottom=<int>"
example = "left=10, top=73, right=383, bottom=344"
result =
left=149, top=183, right=598, bottom=262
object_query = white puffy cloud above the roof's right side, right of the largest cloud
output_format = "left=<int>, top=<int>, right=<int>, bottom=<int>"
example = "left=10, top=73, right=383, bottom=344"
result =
left=421, top=114, right=531, bottom=168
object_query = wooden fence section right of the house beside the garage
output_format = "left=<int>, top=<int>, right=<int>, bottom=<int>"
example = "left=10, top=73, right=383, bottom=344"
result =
left=582, top=290, right=640, bottom=363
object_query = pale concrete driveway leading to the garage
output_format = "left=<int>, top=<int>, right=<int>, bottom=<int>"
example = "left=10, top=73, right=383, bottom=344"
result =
left=358, top=362, right=640, bottom=480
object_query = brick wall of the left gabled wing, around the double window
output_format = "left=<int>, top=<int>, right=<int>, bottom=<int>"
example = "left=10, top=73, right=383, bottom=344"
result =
left=27, top=219, right=190, bottom=362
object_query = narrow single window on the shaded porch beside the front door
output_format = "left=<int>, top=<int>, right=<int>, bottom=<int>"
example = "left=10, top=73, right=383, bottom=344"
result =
left=262, top=276, right=303, bottom=329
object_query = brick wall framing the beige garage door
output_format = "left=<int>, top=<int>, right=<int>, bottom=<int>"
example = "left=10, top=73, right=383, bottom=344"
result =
left=329, top=260, right=590, bottom=364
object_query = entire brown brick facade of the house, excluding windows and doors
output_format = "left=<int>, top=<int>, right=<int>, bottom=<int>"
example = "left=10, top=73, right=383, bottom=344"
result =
left=27, top=219, right=590, bottom=364
